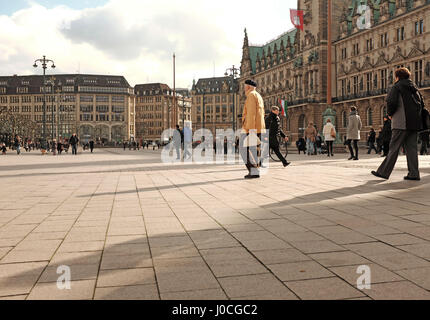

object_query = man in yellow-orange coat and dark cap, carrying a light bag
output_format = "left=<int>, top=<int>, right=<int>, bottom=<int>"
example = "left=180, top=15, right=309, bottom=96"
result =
left=240, top=80, right=266, bottom=179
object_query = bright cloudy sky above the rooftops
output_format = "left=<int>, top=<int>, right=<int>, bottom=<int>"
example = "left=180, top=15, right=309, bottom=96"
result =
left=0, top=0, right=297, bottom=88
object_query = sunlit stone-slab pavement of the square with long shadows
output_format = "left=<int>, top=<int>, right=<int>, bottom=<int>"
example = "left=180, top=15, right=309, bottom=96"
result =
left=0, top=149, right=430, bottom=300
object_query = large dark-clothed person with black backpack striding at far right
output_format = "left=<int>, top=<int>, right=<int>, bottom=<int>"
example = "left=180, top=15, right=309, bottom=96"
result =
left=372, top=68, right=425, bottom=181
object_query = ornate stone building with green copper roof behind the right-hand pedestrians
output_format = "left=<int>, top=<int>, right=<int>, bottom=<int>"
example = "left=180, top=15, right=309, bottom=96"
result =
left=239, top=0, right=430, bottom=142
